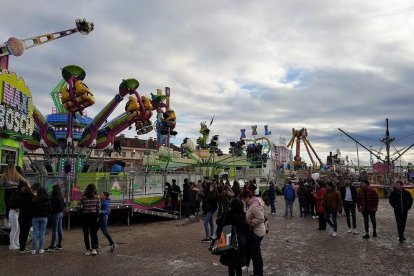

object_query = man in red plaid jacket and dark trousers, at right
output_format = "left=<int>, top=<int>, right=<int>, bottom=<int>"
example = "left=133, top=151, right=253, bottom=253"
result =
left=357, top=179, right=378, bottom=239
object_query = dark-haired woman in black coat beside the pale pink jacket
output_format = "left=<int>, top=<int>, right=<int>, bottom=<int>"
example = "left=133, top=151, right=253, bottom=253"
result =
left=216, top=198, right=249, bottom=276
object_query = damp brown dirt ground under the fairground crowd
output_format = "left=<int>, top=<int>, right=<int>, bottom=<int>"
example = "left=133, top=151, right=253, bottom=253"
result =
left=0, top=197, right=414, bottom=276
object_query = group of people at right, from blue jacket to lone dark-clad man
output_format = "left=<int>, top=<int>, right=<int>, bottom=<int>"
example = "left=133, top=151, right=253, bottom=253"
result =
left=282, top=179, right=413, bottom=242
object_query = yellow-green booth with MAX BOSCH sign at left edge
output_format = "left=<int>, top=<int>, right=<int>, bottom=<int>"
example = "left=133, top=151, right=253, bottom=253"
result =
left=0, top=69, right=34, bottom=217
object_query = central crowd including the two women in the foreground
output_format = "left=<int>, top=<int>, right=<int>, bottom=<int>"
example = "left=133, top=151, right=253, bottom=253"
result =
left=164, top=178, right=264, bottom=275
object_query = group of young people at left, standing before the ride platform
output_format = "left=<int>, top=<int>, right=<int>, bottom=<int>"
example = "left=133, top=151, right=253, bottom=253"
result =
left=2, top=162, right=116, bottom=255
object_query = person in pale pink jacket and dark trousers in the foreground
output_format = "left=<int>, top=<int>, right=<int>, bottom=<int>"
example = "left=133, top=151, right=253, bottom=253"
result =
left=241, top=190, right=266, bottom=276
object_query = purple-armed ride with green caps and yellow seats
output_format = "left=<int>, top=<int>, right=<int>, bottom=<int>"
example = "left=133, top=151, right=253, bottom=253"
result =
left=24, top=65, right=175, bottom=175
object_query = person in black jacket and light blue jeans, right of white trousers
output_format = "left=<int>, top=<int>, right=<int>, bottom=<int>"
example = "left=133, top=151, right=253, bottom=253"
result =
left=32, top=187, right=50, bottom=255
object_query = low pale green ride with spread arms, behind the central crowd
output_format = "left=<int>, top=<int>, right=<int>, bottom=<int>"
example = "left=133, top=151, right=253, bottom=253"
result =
left=143, top=122, right=271, bottom=178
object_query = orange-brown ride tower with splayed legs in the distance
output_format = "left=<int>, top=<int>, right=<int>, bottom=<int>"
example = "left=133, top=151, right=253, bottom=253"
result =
left=286, top=128, right=322, bottom=169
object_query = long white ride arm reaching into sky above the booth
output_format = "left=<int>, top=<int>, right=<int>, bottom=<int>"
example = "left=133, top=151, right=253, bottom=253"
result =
left=0, top=19, right=94, bottom=69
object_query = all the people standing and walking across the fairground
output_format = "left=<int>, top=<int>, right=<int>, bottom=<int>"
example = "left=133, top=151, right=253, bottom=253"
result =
left=3, top=164, right=413, bottom=275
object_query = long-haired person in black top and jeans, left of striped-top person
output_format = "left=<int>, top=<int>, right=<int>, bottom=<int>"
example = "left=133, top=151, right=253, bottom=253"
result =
left=47, top=184, right=65, bottom=251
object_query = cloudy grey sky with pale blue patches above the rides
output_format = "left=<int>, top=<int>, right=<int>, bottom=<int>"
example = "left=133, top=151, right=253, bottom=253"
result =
left=0, top=0, right=414, bottom=166
